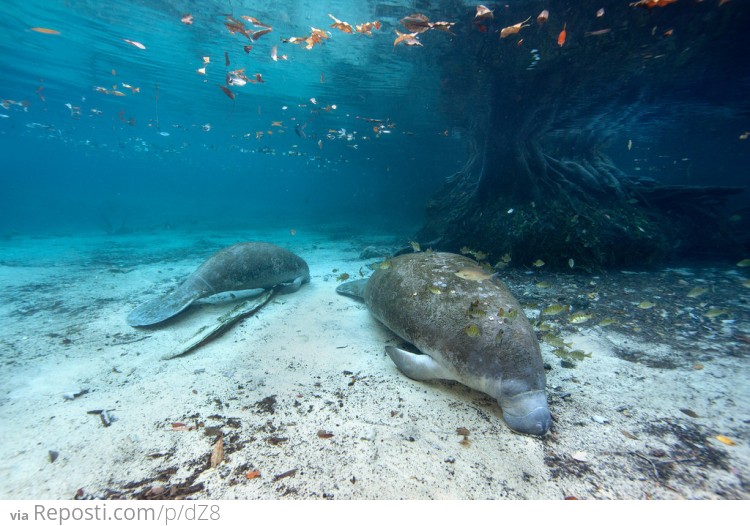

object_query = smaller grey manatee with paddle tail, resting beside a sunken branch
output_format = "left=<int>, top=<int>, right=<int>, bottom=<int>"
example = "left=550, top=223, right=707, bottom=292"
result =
left=127, top=242, right=310, bottom=327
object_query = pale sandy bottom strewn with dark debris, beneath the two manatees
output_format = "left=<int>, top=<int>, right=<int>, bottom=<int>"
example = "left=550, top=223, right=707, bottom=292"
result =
left=0, top=227, right=750, bottom=499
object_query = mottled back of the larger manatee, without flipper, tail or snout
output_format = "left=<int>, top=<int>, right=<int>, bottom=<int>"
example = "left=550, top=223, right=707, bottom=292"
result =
left=364, top=252, right=545, bottom=396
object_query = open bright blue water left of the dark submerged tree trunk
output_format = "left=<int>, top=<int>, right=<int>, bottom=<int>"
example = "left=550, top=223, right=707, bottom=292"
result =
left=0, top=0, right=464, bottom=233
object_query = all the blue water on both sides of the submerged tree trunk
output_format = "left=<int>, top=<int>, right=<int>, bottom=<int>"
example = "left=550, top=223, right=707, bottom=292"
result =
left=0, top=0, right=750, bottom=235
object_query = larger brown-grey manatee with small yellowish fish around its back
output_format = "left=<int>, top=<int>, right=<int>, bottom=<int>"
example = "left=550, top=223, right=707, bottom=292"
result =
left=336, top=252, right=552, bottom=435
